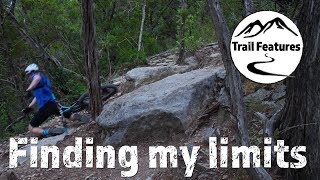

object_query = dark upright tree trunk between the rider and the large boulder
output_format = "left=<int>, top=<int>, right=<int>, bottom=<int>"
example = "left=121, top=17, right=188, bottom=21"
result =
left=82, top=0, right=102, bottom=120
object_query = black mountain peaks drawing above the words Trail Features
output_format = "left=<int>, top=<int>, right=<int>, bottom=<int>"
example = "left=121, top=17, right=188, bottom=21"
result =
left=235, top=17, right=298, bottom=38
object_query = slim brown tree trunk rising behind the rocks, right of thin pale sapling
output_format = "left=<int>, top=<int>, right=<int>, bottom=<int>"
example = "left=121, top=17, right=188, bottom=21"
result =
left=177, top=0, right=188, bottom=64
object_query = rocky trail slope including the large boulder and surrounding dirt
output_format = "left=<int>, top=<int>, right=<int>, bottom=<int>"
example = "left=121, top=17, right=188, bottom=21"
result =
left=0, top=44, right=285, bottom=180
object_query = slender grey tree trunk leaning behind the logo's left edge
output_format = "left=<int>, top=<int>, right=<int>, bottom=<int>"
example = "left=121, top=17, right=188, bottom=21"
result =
left=208, top=0, right=271, bottom=180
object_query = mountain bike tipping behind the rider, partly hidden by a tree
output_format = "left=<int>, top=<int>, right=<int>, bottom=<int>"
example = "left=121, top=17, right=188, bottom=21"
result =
left=5, top=84, right=118, bottom=131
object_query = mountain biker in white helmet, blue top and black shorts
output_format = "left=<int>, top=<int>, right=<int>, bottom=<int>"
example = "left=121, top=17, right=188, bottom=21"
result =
left=22, top=64, right=75, bottom=136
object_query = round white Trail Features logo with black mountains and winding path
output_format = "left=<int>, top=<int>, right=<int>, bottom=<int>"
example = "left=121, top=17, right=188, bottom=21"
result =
left=230, top=11, right=303, bottom=84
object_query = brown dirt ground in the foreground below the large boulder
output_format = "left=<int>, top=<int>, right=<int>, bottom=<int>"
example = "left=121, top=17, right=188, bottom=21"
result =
left=0, top=107, right=255, bottom=180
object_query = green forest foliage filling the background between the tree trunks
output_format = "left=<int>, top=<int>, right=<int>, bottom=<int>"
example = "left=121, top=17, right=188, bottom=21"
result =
left=0, top=0, right=300, bottom=139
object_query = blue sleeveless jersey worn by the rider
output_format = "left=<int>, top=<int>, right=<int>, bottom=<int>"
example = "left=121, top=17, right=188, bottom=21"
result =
left=31, top=73, right=55, bottom=110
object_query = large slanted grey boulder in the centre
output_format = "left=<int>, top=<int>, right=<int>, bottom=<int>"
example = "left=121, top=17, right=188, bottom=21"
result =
left=97, top=67, right=225, bottom=145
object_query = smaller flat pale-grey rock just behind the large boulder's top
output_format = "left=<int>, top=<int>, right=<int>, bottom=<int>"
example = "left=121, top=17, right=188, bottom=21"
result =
left=125, top=66, right=194, bottom=87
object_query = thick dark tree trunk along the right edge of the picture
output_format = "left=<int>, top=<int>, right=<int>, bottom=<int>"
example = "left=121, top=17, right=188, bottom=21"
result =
left=281, top=0, right=320, bottom=179
